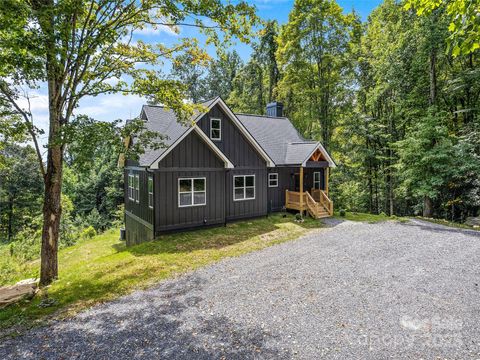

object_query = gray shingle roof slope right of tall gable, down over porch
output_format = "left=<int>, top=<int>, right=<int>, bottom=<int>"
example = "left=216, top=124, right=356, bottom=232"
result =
left=236, top=114, right=318, bottom=165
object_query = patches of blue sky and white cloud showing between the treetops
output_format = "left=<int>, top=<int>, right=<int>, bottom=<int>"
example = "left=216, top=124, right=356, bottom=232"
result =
left=26, top=0, right=381, bottom=148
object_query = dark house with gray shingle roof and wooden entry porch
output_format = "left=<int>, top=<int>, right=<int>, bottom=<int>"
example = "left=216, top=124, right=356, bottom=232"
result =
left=124, top=97, right=335, bottom=245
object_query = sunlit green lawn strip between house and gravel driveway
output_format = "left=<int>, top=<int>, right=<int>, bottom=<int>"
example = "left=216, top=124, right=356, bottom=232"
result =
left=0, top=214, right=321, bottom=335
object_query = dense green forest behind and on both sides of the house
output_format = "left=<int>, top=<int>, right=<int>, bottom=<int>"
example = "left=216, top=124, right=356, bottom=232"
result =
left=0, top=0, right=480, bottom=259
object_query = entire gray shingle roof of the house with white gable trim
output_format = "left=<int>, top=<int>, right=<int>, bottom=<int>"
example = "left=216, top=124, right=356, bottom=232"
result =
left=131, top=97, right=336, bottom=168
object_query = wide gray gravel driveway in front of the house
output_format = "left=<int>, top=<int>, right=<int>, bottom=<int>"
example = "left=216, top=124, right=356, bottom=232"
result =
left=0, top=220, right=480, bottom=359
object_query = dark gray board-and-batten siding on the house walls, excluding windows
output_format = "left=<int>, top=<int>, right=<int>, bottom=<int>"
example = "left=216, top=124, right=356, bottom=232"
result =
left=125, top=105, right=324, bottom=243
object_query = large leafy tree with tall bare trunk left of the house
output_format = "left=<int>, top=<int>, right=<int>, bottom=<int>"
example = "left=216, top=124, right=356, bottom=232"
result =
left=0, top=0, right=256, bottom=285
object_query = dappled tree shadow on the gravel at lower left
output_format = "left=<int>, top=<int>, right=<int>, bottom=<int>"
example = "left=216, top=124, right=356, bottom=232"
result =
left=0, top=274, right=292, bottom=359
